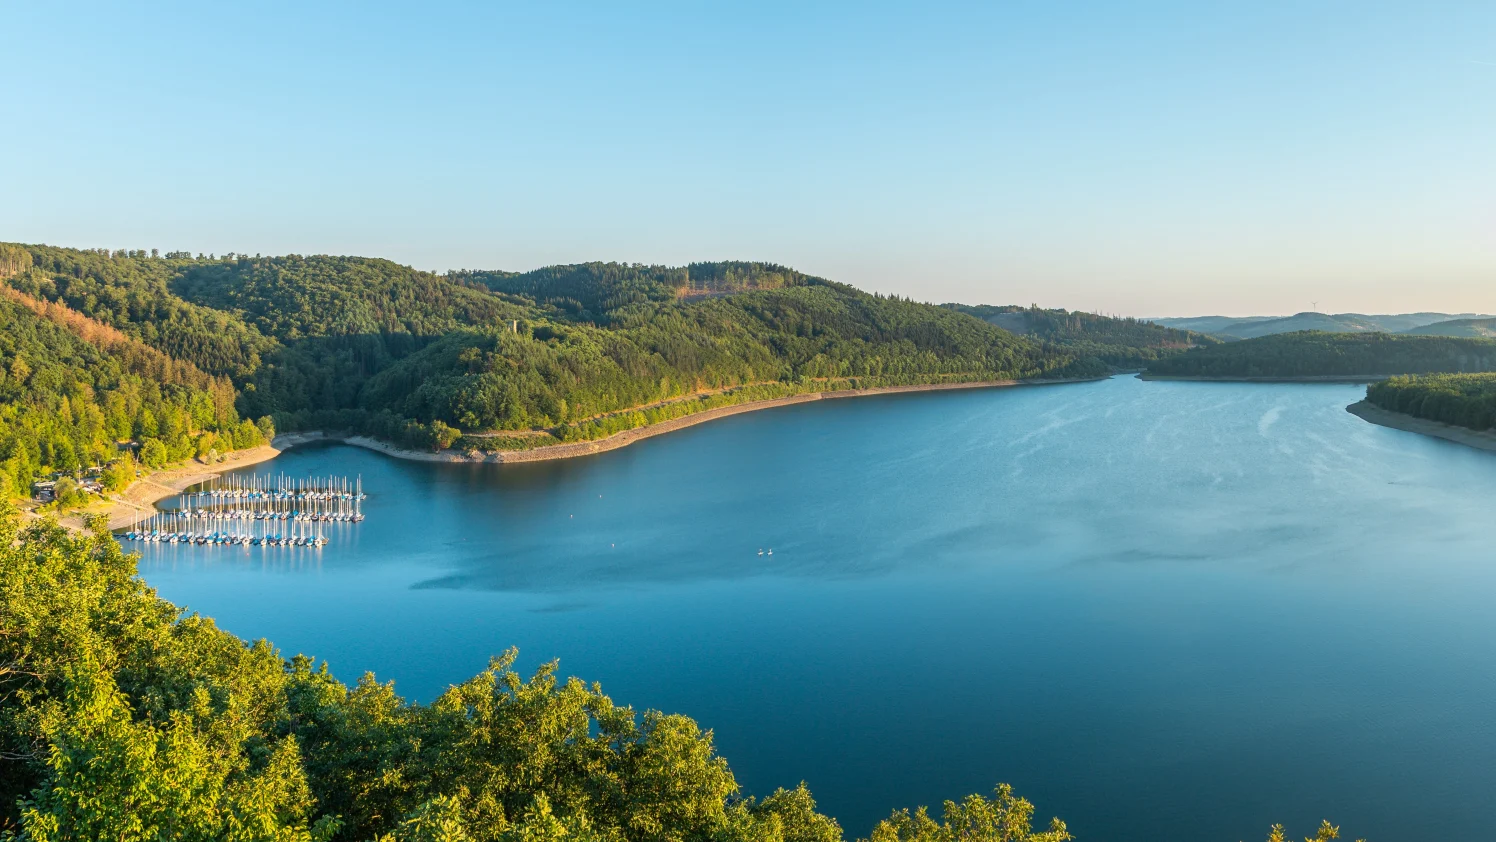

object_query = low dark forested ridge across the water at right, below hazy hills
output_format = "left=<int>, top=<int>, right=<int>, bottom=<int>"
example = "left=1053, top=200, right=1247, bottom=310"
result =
left=1147, top=331, right=1496, bottom=378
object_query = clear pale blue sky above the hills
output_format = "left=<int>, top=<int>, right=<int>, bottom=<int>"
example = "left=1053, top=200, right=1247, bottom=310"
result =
left=0, top=0, right=1496, bottom=316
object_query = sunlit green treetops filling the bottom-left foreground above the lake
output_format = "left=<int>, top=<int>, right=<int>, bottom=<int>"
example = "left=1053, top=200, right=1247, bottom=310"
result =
left=0, top=510, right=1071, bottom=842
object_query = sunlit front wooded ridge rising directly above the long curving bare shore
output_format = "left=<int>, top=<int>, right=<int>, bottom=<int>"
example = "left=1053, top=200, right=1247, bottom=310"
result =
left=354, top=284, right=1083, bottom=440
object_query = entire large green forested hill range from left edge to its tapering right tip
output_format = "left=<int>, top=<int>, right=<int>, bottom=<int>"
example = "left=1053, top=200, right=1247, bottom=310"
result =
left=0, top=244, right=1106, bottom=491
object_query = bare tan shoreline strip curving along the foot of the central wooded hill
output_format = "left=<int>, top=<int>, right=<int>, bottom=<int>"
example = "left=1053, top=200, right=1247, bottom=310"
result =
left=281, top=375, right=1110, bottom=465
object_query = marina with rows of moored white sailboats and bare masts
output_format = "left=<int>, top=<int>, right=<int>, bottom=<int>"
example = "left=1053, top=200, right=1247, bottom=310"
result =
left=120, top=474, right=368, bottom=549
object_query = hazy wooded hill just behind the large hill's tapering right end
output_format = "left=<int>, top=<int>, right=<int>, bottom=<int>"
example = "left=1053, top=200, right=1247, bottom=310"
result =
left=944, top=304, right=1221, bottom=368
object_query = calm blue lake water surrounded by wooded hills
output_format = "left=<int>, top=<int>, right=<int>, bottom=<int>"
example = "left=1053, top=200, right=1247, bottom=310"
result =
left=141, top=377, right=1496, bottom=842
